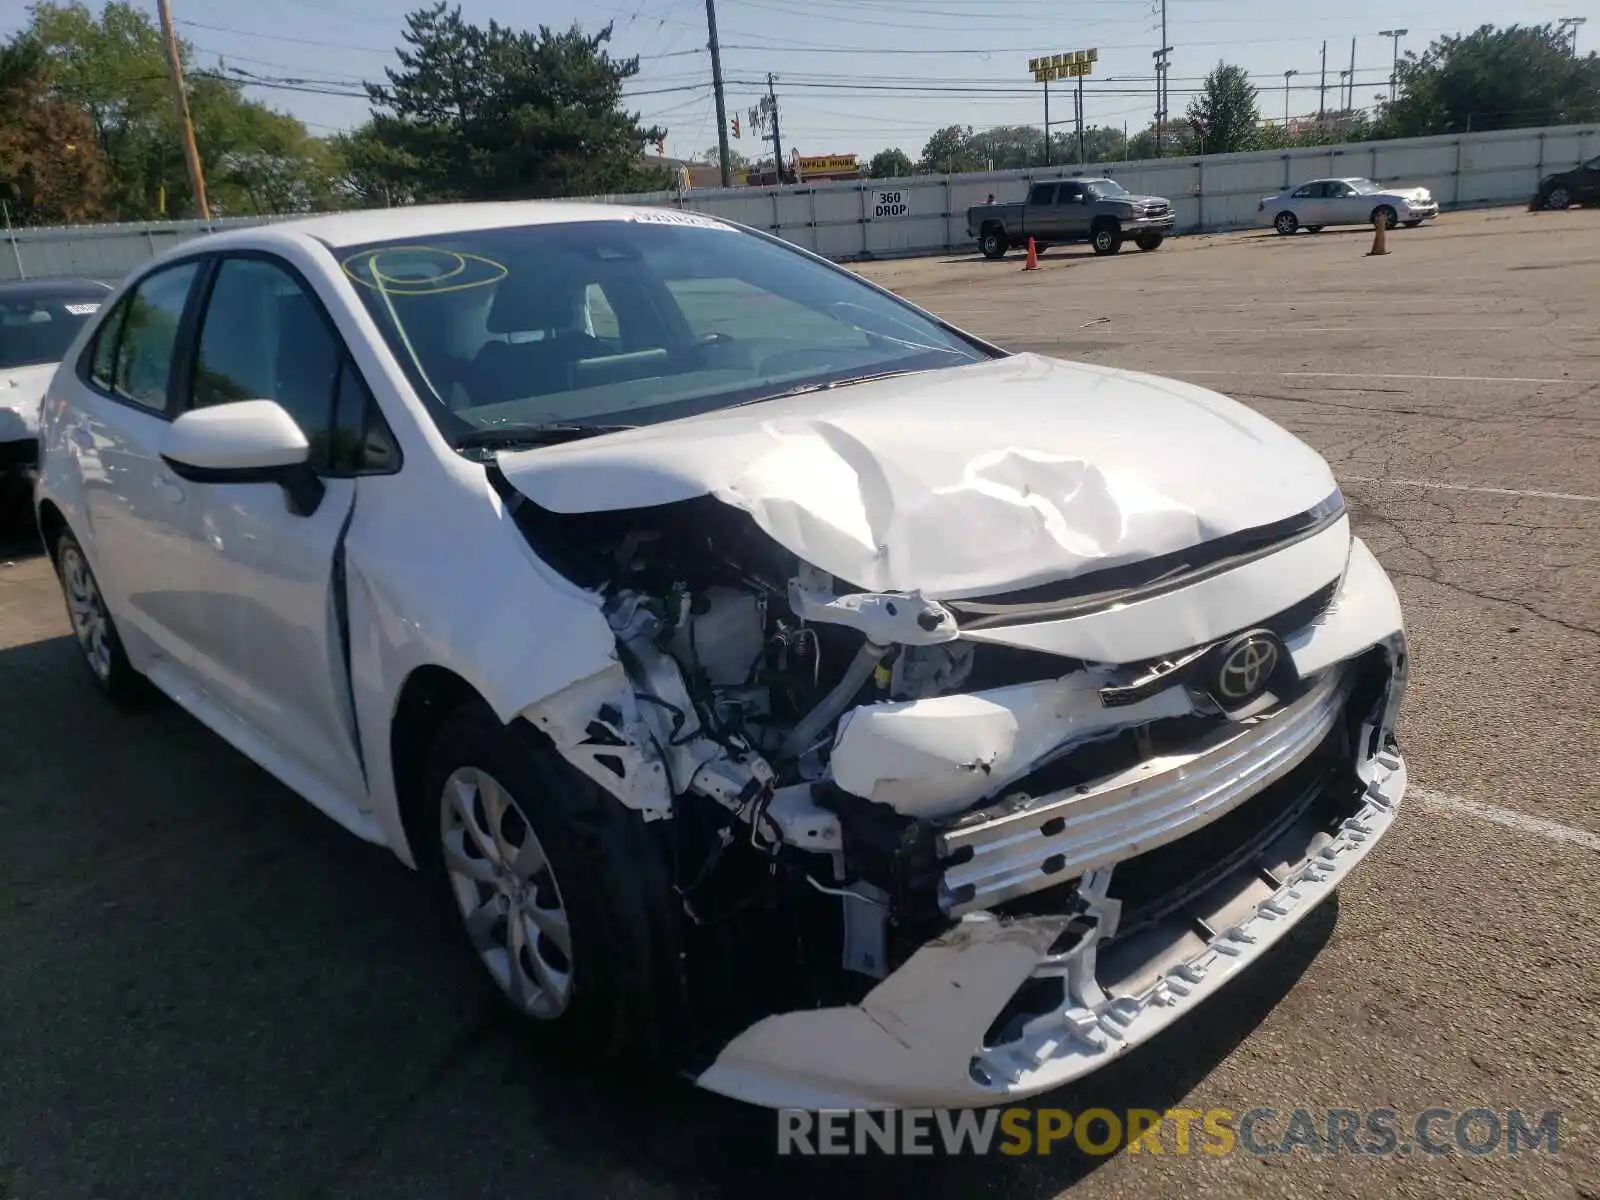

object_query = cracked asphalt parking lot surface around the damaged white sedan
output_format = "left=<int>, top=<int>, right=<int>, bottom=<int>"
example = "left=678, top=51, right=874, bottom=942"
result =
left=0, top=210, right=1600, bottom=1200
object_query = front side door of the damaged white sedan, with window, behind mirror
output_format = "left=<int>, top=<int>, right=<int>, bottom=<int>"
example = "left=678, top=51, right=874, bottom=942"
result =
left=168, top=254, right=398, bottom=802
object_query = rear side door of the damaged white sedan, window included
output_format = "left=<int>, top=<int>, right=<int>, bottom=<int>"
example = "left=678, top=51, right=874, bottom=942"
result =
left=70, top=259, right=203, bottom=670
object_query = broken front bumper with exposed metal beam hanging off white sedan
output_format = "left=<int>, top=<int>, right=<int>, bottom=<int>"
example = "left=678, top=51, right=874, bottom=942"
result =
left=698, top=541, right=1406, bottom=1109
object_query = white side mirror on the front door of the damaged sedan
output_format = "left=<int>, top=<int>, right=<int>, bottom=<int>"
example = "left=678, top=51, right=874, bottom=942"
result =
left=162, top=400, right=325, bottom=517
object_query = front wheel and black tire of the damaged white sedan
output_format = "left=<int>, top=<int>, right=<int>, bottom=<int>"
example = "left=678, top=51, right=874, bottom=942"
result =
left=410, top=709, right=677, bottom=1061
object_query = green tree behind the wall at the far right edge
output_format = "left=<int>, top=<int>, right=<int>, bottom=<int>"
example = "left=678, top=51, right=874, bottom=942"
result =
left=1379, top=26, right=1600, bottom=138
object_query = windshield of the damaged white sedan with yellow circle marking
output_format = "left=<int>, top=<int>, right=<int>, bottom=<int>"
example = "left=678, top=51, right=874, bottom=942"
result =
left=336, top=211, right=990, bottom=445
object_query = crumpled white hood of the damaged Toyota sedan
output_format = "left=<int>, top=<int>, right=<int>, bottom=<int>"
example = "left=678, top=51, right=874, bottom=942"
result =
left=498, top=354, right=1336, bottom=598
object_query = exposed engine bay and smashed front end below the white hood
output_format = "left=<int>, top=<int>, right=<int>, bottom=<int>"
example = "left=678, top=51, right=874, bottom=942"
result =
left=502, top=473, right=1403, bottom=1100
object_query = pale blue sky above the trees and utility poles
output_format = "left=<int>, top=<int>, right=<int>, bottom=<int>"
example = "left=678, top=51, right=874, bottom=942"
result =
left=0, top=0, right=1600, bottom=157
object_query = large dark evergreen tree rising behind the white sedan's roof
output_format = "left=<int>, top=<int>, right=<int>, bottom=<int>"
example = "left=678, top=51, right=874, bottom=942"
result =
left=368, top=0, right=670, bottom=200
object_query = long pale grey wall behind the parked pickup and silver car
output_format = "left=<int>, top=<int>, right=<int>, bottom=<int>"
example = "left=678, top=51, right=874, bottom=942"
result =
left=0, top=125, right=1600, bottom=280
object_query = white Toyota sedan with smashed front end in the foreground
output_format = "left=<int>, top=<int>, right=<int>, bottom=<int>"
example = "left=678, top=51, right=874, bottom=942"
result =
left=35, top=203, right=1406, bottom=1107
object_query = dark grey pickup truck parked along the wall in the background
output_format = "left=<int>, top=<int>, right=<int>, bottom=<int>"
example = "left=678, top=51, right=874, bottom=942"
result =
left=966, top=179, right=1176, bottom=258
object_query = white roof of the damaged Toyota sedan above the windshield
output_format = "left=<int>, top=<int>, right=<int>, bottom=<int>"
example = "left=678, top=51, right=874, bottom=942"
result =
left=222, top=200, right=715, bottom=246
